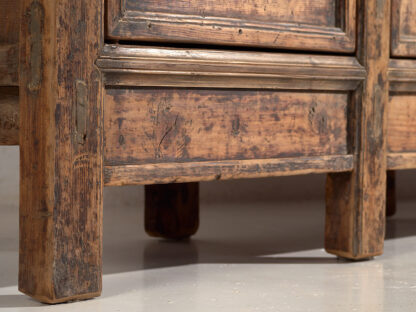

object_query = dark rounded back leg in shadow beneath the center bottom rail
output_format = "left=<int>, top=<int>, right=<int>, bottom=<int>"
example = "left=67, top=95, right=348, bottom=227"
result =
left=144, top=183, right=199, bottom=239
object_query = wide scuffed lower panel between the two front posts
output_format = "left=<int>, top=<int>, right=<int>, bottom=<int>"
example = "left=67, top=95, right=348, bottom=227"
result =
left=104, top=88, right=348, bottom=165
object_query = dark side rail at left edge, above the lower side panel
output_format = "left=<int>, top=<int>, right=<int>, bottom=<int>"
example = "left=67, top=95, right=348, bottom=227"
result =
left=0, top=44, right=19, bottom=86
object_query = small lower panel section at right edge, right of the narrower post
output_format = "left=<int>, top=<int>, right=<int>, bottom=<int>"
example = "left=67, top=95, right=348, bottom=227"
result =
left=387, top=94, right=416, bottom=153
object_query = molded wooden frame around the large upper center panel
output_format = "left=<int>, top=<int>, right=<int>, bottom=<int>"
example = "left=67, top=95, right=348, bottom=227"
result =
left=106, top=0, right=356, bottom=53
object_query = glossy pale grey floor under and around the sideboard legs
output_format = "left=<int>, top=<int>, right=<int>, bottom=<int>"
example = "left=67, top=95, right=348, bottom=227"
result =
left=0, top=149, right=416, bottom=312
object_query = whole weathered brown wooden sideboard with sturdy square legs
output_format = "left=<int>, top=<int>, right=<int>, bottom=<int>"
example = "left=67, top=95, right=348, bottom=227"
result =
left=0, top=0, right=416, bottom=303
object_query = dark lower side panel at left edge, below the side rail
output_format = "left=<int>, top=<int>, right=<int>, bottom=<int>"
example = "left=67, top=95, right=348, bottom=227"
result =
left=0, top=87, right=19, bottom=145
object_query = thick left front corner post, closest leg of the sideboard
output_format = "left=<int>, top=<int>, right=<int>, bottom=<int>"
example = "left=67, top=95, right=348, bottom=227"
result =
left=19, top=0, right=103, bottom=303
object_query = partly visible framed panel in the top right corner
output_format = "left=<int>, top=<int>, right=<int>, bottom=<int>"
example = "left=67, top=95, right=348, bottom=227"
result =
left=391, top=0, right=416, bottom=57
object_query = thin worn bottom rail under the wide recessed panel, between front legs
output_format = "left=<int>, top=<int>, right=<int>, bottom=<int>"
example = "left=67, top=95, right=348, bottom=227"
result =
left=104, top=155, right=354, bottom=186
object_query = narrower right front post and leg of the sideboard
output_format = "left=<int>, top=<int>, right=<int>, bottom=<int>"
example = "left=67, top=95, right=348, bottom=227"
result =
left=325, top=0, right=391, bottom=259
